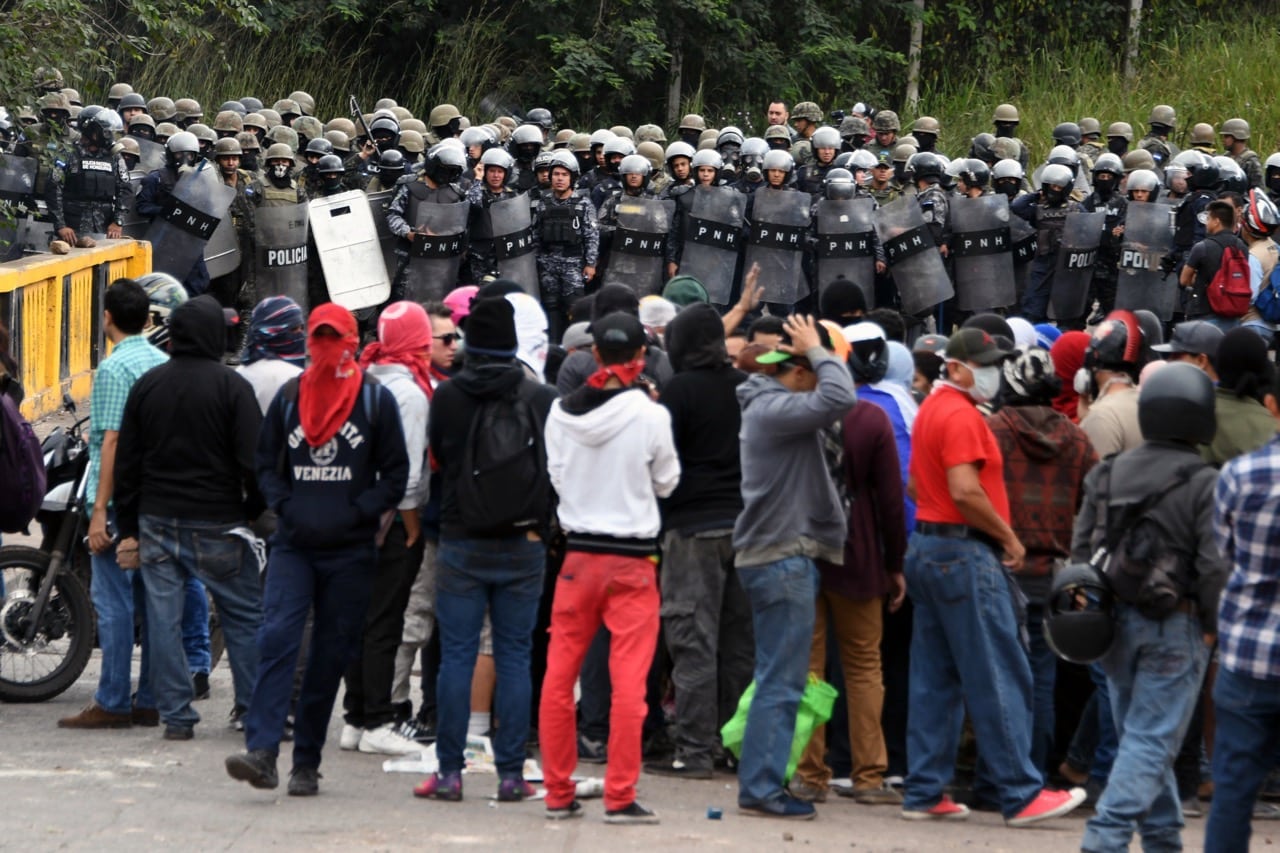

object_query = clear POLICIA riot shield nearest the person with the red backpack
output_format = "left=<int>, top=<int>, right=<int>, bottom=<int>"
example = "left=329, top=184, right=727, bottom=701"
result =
left=1116, top=201, right=1178, bottom=320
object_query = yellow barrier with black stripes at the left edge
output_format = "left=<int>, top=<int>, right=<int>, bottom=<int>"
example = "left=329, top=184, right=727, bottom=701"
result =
left=0, top=240, right=151, bottom=419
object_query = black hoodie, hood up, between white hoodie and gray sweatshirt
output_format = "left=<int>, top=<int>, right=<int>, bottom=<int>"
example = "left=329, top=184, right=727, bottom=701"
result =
left=658, top=304, right=746, bottom=532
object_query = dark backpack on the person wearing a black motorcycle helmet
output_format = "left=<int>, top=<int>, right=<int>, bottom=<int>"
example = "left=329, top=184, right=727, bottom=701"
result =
left=1091, top=459, right=1204, bottom=620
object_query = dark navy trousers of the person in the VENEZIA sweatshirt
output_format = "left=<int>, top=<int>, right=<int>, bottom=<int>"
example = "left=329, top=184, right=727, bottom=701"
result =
left=243, top=534, right=378, bottom=767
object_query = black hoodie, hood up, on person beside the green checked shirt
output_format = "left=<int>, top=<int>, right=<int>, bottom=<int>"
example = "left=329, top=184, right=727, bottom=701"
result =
left=114, top=296, right=264, bottom=538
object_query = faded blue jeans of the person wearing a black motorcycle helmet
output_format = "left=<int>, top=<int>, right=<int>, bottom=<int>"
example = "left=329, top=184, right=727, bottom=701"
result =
left=1080, top=605, right=1208, bottom=853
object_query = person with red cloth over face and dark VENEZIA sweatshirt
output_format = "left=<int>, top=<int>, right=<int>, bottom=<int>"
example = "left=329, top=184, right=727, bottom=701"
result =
left=227, top=302, right=410, bottom=797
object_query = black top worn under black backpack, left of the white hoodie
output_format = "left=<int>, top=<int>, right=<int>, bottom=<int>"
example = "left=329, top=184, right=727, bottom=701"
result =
left=428, top=356, right=556, bottom=539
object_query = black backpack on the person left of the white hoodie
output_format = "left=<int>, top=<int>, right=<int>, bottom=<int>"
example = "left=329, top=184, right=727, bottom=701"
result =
left=454, top=391, right=550, bottom=537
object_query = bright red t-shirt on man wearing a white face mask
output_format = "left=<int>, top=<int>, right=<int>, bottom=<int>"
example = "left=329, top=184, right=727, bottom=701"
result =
left=911, top=386, right=1009, bottom=524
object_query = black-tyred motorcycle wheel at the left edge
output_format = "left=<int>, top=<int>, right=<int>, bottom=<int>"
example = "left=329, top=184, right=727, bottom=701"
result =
left=0, top=546, right=93, bottom=702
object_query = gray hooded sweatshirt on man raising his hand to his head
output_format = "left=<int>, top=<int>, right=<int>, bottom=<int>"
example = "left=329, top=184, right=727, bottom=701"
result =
left=733, top=347, right=858, bottom=566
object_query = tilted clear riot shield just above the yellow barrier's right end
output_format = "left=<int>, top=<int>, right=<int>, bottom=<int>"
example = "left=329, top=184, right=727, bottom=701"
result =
left=146, top=164, right=236, bottom=282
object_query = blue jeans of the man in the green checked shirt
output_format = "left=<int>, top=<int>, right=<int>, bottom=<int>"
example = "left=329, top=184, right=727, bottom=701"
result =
left=90, top=537, right=155, bottom=713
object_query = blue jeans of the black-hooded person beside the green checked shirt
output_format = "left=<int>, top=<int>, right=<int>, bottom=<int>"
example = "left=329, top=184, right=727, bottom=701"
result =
left=138, top=515, right=262, bottom=726
